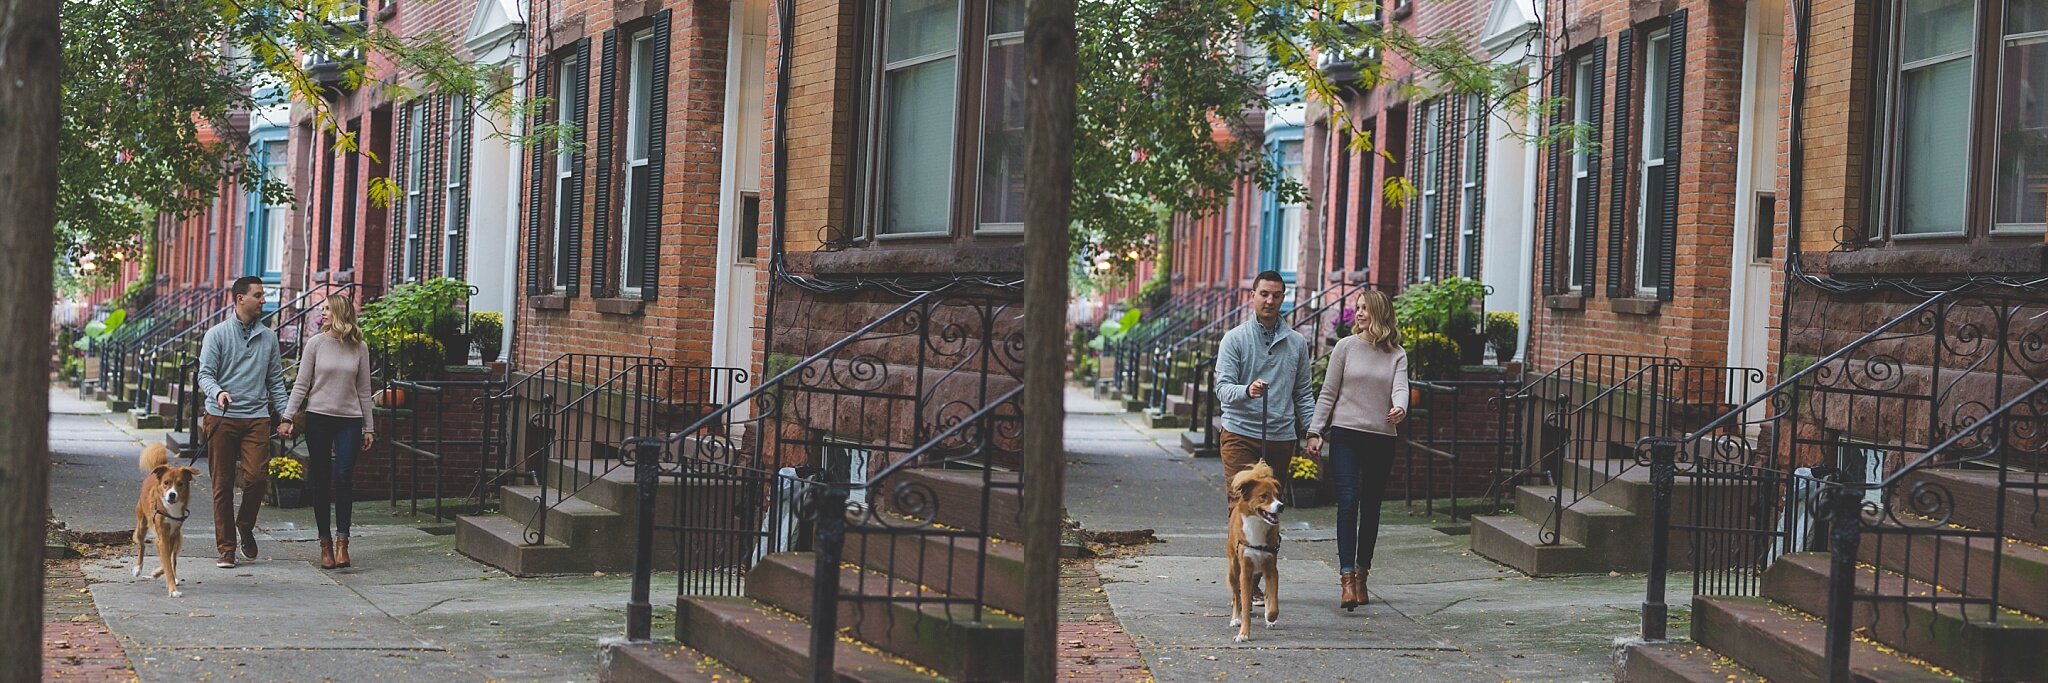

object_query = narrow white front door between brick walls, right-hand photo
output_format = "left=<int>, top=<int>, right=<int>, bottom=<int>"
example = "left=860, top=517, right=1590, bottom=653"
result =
left=1729, top=0, right=1786, bottom=393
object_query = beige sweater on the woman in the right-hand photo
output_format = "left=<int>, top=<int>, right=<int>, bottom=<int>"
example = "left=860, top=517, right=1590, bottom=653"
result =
left=1309, top=334, right=1407, bottom=437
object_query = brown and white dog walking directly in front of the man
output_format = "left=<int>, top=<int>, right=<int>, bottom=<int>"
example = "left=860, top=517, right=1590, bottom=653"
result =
left=1229, top=461, right=1286, bottom=642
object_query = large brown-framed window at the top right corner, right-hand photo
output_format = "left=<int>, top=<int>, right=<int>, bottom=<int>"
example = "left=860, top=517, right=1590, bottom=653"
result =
left=1868, top=0, right=2048, bottom=240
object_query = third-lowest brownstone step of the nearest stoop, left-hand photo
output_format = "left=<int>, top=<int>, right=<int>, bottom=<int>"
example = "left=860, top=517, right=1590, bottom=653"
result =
left=748, top=552, right=1024, bottom=681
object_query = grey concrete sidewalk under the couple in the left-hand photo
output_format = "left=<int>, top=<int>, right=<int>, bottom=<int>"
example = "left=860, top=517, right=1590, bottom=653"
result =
left=51, top=390, right=674, bottom=681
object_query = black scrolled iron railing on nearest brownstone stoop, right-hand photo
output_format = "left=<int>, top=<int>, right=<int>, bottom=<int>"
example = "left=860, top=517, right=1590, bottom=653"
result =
left=1640, top=289, right=2048, bottom=681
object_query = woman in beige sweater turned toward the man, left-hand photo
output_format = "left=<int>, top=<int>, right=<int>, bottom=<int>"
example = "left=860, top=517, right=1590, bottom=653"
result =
left=281, top=295, right=377, bottom=568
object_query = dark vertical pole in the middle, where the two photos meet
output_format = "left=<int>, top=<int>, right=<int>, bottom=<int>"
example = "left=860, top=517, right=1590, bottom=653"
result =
left=1022, top=0, right=1079, bottom=672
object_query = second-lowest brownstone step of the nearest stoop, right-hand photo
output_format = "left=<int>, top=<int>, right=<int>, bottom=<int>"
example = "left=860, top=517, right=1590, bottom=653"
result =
left=1692, top=595, right=1956, bottom=683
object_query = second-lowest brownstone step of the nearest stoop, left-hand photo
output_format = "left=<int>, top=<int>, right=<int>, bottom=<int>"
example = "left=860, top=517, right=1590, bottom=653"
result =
left=676, top=597, right=942, bottom=683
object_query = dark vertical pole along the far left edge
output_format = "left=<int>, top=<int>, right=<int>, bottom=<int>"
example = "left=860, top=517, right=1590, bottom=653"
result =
left=0, top=0, right=63, bottom=681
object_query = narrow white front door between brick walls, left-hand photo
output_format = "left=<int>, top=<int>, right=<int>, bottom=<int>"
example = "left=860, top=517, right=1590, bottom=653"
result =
left=711, top=0, right=768, bottom=385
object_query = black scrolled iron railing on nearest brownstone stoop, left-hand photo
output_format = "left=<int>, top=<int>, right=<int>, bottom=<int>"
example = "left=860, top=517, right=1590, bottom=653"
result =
left=627, top=291, right=1024, bottom=671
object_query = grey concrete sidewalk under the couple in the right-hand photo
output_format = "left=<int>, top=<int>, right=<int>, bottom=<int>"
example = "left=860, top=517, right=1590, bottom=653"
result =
left=1067, top=390, right=1690, bottom=681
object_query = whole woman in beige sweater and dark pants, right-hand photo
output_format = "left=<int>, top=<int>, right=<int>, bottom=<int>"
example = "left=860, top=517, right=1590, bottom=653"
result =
left=1309, top=291, right=1409, bottom=609
